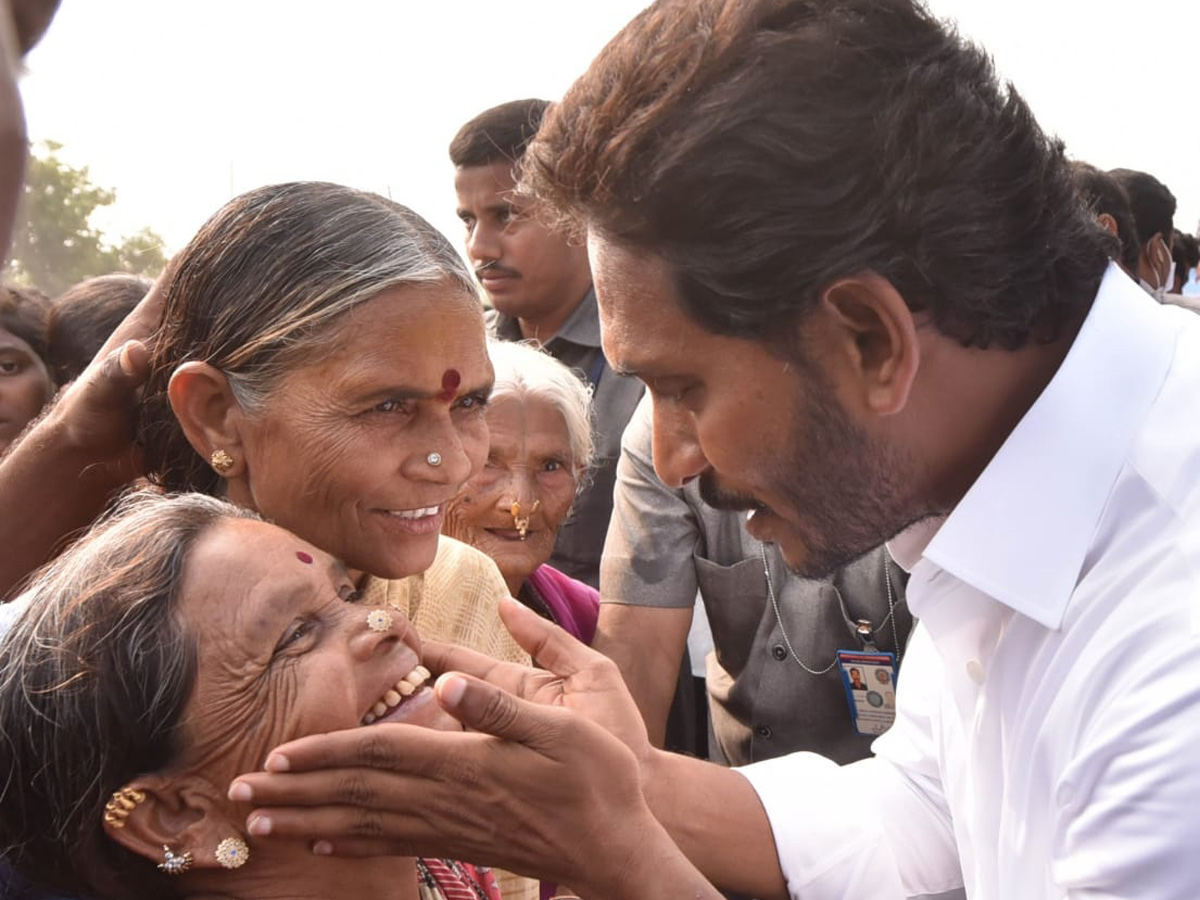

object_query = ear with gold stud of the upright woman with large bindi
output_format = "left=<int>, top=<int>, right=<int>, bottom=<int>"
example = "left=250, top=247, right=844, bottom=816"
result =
left=167, top=361, right=246, bottom=479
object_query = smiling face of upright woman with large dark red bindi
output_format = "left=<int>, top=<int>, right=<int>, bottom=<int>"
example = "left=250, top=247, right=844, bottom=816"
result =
left=229, top=282, right=492, bottom=578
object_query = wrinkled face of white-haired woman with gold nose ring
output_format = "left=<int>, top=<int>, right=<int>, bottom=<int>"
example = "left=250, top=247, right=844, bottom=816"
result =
left=446, top=395, right=578, bottom=583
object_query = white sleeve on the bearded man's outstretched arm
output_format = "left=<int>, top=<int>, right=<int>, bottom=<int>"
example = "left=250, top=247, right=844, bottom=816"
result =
left=739, top=626, right=962, bottom=900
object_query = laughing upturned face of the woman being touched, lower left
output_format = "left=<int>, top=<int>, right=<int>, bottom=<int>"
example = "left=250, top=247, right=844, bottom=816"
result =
left=180, top=520, right=458, bottom=782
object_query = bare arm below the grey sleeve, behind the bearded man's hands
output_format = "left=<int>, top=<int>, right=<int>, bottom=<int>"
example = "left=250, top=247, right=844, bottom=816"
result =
left=592, top=602, right=692, bottom=748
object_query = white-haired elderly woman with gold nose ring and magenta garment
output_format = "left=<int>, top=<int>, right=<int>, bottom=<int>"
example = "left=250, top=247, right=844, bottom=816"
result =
left=444, top=341, right=600, bottom=643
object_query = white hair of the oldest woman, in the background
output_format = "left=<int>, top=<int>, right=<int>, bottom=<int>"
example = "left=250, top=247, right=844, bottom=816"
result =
left=487, top=340, right=595, bottom=490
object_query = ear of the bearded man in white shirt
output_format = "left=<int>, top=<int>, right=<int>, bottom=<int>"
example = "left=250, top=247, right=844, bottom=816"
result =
left=818, top=272, right=920, bottom=415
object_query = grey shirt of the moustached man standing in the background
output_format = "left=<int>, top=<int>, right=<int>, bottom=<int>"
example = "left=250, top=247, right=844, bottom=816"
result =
left=487, top=288, right=644, bottom=587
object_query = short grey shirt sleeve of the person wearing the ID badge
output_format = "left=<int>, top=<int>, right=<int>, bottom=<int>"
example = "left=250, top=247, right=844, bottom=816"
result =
left=600, top=396, right=698, bottom=610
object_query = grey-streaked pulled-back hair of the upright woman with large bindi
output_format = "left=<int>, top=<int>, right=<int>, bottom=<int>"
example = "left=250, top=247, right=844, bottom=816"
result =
left=139, top=181, right=476, bottom=493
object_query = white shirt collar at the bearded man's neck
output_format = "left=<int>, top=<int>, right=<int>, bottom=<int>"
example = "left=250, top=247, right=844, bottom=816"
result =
left=924, top=264, right=1178, bottom=629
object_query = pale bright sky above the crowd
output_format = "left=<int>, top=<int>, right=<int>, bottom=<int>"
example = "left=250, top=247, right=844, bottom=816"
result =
left=16, top=0, right=1200, bottom=260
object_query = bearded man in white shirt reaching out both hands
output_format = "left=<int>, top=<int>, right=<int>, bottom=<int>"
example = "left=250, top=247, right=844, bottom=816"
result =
left=230, top=0, right=1200, bottom=900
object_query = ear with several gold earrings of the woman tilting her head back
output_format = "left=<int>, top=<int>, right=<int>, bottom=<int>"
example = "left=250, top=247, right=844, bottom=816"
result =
left=104, top=775, right=250, bottom=869
